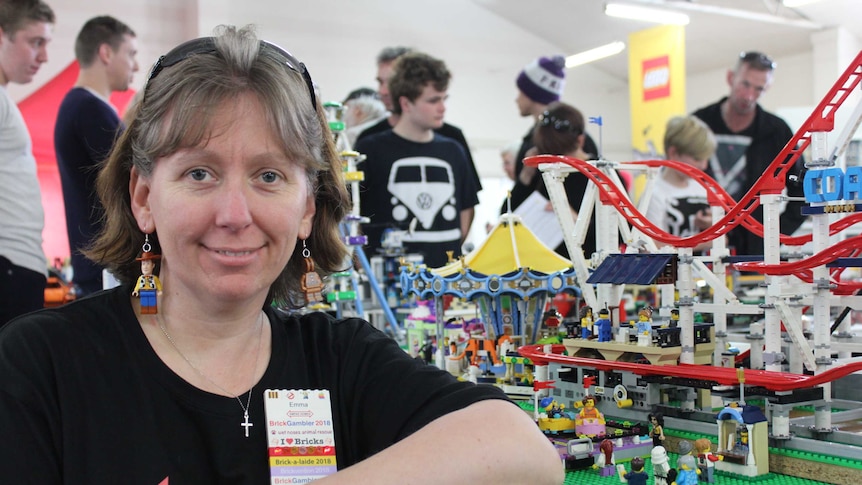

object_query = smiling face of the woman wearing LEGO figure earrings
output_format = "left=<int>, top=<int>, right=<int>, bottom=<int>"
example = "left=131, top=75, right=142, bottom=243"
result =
left=130, top=94, right=315, bottom=305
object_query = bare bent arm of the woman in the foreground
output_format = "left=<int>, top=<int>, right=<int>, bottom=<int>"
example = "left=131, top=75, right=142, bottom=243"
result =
left=315, top=399, right=564, bottom=485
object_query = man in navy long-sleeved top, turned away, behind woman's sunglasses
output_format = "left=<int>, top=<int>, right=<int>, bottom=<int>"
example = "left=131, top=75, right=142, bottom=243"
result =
left=54, top=16, right=138, bottom=296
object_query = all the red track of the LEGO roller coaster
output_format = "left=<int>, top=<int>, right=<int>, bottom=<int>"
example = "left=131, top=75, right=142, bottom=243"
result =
left=518, top=52, right=862, bottom=391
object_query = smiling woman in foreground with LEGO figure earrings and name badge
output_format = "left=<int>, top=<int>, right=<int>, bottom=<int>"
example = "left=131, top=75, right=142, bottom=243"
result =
left=0, top=27, right=563, bottom=485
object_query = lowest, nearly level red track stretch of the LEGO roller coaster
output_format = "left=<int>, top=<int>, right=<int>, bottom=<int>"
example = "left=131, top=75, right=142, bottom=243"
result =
left=518, top=344, right=862, bottom=392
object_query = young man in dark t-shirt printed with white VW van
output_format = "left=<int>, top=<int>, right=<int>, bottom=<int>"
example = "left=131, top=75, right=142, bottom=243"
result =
left=355, top=52, right=479, bottom=267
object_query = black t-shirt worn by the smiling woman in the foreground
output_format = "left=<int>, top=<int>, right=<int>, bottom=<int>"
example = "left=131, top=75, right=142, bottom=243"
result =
left=0, top=286, right=505, bottom=485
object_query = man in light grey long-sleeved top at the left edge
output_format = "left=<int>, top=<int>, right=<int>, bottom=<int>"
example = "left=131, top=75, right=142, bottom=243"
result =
left=0, top=0, right=54, bottom=326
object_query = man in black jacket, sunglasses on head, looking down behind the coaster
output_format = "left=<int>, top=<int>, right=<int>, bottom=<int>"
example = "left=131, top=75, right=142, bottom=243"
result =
left=694, top=51, right=804, bottom=255
